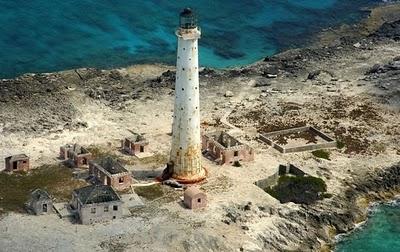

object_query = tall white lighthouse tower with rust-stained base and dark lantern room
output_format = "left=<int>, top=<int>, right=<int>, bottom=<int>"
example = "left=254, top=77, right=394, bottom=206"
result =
left=169, top=8, right=206, bottom=183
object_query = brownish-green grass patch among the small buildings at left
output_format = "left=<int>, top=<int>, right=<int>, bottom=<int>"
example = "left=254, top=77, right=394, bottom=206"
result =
left=0, top=164, right=87, bottom=213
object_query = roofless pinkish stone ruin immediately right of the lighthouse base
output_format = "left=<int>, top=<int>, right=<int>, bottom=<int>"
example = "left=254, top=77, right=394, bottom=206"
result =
left=202, top=131, right=254, bottom=165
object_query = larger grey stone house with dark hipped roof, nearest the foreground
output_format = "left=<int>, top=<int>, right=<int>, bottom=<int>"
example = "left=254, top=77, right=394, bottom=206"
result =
left=71, top=185, right=123, bottom=224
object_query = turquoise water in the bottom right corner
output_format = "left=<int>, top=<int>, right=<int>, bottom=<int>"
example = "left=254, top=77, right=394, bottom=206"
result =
left=336, top=201, right=400, bottom=252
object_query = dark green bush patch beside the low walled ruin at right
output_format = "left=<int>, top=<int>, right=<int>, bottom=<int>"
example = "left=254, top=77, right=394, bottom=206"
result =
left=265, top=176, right=331, bottom=204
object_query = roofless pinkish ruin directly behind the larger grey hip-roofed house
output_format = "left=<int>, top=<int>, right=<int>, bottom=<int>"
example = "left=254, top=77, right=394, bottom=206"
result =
left=89, top=157, right=132, bottom=191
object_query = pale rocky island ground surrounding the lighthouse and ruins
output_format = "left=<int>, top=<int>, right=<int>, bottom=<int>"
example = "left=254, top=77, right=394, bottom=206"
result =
left=0, top=4, right=400, bottom=251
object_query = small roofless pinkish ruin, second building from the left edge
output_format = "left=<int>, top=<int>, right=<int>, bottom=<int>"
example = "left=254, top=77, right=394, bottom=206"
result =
left=60, top=144, right=92, bottom=167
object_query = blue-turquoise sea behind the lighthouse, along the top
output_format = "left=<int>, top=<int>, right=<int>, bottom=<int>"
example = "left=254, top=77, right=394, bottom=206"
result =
left=0, top=0, right=382, bottom=77
